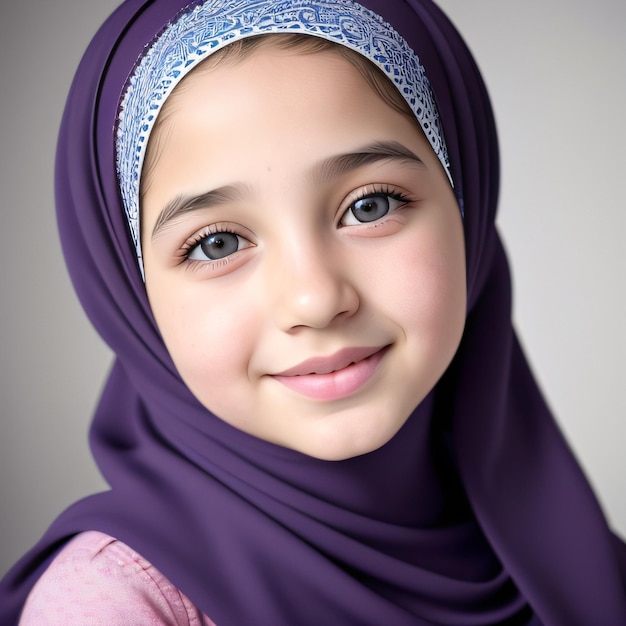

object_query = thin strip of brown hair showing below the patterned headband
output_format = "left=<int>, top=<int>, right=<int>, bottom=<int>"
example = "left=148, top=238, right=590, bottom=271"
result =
left=139, top=33, right=419, bottom=197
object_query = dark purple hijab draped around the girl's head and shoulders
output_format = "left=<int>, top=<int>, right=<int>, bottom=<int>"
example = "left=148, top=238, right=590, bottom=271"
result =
left=0, top=0, right=626, bottom=626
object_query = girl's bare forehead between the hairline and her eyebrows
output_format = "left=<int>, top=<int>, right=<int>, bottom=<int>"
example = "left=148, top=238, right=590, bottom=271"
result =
left=142, top=46, right=435, bottom=195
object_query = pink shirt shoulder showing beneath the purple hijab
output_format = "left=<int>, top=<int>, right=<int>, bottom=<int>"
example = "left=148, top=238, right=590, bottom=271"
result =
left=19, top=531, right=215, bottom=626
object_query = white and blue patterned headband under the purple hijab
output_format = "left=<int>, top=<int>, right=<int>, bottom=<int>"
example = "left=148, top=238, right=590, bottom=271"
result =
left=116, top=0, right=452, bottom=274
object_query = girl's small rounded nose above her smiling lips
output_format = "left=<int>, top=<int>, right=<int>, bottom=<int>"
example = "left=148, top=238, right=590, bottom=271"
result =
left=268, top=238, right=360, bottom=332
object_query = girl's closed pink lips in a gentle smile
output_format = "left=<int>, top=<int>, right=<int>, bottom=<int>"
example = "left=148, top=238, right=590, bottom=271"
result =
left=273, top=346, right=388, bottom=401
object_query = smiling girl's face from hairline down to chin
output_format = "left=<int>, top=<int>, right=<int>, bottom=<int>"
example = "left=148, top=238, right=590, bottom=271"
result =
left=142, top=46, right=466, bottom=460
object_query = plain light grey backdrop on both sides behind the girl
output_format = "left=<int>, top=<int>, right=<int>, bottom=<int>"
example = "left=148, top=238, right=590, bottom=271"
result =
left=0, top=0, right=626, bottom=574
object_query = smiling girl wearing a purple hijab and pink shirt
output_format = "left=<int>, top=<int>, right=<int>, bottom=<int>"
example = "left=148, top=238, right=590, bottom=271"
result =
left=1, top=0, right=626, bottom=626
